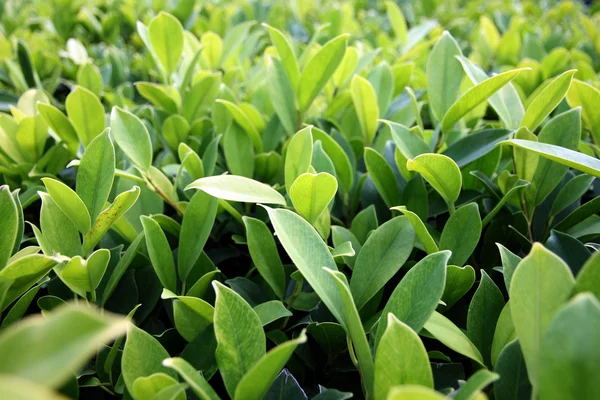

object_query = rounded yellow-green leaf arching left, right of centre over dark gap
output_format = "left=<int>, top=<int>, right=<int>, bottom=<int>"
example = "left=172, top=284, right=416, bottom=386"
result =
left=406, top=154, right=462, bottom=207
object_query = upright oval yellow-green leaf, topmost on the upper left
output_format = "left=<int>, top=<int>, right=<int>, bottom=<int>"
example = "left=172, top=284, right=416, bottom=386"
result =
left=148, top=11, right=183, bottom=75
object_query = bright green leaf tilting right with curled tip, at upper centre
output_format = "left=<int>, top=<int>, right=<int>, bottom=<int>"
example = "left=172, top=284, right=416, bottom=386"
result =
left=297, top=34, right=350, bottom=112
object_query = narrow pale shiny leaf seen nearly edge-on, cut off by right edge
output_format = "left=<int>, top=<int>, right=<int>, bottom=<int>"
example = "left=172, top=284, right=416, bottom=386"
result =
left=500, top=139, right=600, bottom=178
